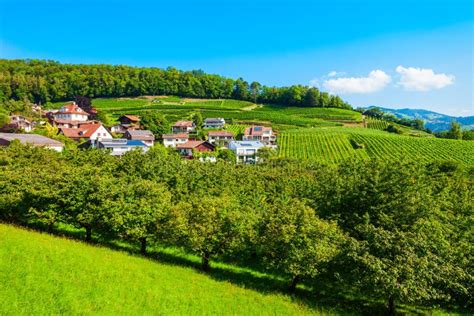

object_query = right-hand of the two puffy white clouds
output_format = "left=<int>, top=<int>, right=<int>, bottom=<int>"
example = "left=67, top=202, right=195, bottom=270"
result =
left=396, top=66, right=455, bottom=91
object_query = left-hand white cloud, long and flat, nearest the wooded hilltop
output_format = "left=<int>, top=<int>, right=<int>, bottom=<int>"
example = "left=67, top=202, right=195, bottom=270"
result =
left=323, top=70, right=392, bottom=94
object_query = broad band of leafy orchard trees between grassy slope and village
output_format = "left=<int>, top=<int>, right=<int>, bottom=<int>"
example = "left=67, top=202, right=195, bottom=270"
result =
left=0, top=144, right=473, bottom=314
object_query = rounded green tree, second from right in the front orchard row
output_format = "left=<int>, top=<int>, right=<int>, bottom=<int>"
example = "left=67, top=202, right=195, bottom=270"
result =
left=261, top=199, right=344, bottom=291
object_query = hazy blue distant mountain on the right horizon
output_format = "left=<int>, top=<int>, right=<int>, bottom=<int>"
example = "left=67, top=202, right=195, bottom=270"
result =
left=368, top=106, right=474, bottom=132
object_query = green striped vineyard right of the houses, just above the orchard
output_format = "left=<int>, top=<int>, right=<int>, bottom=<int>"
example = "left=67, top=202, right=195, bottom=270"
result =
left=278, top=128, right=474, bottom=164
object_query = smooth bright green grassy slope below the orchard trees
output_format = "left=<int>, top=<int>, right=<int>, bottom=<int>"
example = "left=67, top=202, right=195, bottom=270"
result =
left=0, top=224, right=326, bottom=315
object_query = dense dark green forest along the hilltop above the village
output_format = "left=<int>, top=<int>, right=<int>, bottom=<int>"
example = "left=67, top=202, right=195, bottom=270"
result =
left=0, top=59, right=351, bottom=109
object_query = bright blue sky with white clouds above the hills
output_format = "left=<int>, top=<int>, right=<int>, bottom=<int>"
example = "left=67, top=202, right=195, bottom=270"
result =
left=0, top=0, right=474, bottom=115
